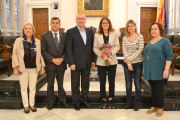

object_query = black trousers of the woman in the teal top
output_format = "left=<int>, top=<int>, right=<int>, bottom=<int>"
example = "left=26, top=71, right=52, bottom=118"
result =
left=148, top=79, right=167, bottom=108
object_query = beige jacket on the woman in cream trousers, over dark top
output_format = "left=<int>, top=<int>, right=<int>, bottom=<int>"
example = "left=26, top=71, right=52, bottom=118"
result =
left=12, top=37, right=45, bottom=72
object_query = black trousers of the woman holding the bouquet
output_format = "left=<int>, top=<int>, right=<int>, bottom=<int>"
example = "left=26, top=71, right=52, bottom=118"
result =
left=97, top=65, right=117, bottom=99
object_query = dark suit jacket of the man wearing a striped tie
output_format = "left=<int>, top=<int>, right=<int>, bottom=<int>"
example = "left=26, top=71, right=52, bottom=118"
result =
left=41, top=31, right=67, bottom=71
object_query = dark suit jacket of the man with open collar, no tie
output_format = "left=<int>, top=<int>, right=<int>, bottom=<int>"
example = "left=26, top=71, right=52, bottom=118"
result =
left=66, top=26, right=95, bottom=69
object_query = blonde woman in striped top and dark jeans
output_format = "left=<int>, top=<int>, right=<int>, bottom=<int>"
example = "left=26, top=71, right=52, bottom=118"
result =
left=122, top=20, right=144, bottom=111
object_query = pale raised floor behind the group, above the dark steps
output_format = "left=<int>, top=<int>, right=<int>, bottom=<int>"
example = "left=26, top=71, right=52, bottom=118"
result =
left=0, top=64, right=180, bottom=91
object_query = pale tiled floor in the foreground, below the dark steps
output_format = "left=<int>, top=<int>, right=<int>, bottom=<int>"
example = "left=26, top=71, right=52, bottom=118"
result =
left=0, top=108, right=180, bottom=120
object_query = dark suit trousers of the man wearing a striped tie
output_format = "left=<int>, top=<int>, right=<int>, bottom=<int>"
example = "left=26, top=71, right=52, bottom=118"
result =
left=46, top=70, right=66, bottom=104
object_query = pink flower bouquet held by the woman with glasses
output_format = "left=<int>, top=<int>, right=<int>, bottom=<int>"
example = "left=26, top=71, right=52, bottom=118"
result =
left=98, top=43, right=113, bottom=66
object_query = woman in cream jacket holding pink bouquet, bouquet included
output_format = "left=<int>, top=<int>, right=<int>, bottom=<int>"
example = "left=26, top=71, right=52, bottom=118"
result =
left=93, top=17, right=120, bottom=108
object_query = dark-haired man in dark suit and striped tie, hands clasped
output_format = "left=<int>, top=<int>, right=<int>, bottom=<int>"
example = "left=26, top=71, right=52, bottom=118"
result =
left=41, top=17, right=68, bottom=110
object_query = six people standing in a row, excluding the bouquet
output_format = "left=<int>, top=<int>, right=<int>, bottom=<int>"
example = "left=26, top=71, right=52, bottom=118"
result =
left=12, top=13, right=173, bottom=116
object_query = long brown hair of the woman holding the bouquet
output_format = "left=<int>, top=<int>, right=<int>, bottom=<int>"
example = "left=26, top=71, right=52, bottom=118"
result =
left=97, top=17, right=114, bottom=34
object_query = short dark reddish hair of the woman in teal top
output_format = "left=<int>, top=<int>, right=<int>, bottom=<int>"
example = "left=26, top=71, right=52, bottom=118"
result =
left=148, top=22, right=165, bottom=38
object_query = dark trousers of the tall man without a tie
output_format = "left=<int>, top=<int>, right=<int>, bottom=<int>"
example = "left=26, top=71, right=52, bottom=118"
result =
left=71, top=68, right=90, bottom=104
